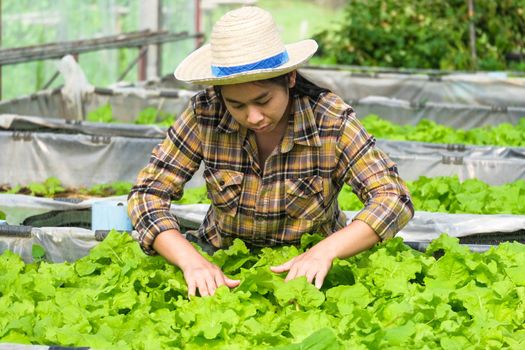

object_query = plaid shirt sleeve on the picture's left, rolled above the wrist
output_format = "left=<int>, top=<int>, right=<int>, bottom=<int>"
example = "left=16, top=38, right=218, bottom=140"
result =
left=128, top=107, right=202, bottom=255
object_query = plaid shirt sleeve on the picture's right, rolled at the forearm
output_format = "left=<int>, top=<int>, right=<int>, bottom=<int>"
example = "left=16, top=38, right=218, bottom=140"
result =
left=340, top=118, right=414, bottom=240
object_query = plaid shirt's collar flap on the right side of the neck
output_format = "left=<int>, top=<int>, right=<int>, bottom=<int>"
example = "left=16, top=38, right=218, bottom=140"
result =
left=281, top=95, right=321, bottom=153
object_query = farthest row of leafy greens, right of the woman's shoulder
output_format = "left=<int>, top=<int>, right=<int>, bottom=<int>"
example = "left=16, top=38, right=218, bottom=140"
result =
left=361, top=114, right=525, bottom=147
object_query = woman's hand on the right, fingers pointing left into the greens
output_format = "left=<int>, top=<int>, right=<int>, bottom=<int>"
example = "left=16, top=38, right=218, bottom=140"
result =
left=270, top=244, right=335, bottom=288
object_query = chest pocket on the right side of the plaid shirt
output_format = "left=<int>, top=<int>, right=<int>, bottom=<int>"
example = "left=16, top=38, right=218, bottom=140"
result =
left=285, top=175, right=324, bottom=220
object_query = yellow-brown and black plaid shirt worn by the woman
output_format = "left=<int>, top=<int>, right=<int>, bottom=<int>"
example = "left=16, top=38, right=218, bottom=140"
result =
left=128, top=88, right=414, bottom=254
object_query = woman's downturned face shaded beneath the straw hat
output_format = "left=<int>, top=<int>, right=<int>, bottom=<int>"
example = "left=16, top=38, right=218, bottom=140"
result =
left=221, top=74, right=295, bottom=134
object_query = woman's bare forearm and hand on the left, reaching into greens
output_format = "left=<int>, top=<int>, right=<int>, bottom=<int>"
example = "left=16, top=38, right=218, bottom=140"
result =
left=153, top=230, right=240, bottom=297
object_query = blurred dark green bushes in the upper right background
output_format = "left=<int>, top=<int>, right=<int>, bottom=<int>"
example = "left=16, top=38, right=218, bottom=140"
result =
left=316, top=0, right=525, bottom=70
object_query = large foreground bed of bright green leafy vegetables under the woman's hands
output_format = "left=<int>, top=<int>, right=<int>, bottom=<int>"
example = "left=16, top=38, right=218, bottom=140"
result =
left=0, top=232, right=525, bottom=349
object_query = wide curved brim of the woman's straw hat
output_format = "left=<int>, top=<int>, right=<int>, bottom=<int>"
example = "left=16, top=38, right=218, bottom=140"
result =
left=174, top=39, right=317, bottom=85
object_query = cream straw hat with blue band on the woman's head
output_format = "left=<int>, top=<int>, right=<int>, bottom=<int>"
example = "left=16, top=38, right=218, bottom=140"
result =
left=175, top=7, right=317, bottom=85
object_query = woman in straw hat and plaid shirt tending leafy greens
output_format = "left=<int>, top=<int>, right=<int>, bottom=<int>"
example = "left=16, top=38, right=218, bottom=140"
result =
left=129, top=7, right=413, bottom=296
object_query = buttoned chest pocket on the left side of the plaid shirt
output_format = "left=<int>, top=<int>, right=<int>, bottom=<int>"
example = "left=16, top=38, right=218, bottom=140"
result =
left=204, top=168, right=244, bottom=216
